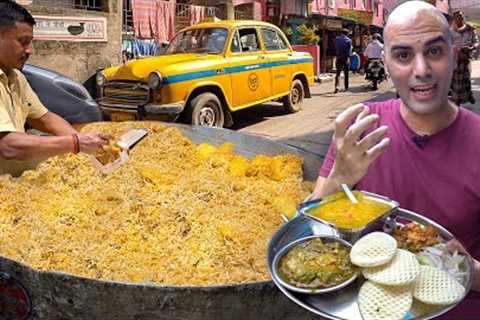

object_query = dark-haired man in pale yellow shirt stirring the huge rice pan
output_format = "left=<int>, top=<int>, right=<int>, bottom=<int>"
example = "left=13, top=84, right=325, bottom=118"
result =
left=0, top=0, right=108, bottom=175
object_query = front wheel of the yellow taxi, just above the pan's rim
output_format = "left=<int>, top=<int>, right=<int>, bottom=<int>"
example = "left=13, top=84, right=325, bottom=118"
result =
left=187, top=92, right=225, bottom=127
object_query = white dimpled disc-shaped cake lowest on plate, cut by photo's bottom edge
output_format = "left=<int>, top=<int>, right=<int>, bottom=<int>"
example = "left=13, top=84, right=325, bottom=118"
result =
left=358, top=281, right=413, bottom=320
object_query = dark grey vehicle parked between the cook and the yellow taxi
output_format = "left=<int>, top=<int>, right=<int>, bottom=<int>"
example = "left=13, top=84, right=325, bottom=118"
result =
left=22, top=64, right=102, bottom=124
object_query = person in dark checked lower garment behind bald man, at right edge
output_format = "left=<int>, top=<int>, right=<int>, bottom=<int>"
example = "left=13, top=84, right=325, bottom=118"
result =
left=451, top=11, right=479, bottom=104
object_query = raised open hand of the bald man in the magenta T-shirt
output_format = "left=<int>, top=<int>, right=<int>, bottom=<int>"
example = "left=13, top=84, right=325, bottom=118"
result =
left=329, top=104, right=390, bottom=187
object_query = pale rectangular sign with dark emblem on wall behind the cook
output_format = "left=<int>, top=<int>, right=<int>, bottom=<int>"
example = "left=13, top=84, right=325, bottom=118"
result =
left=33, top=16, right=107, bottom=42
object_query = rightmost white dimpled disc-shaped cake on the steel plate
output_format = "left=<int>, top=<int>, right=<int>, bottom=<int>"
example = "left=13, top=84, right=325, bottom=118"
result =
left=413, top=266, right=465, bottom=305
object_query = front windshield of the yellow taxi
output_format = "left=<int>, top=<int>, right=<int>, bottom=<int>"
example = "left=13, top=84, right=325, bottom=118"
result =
left=166, top=28, right=228, bottom=54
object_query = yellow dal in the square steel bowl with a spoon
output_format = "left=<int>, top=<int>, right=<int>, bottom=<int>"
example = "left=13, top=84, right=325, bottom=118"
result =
left=308, top=191, right=390, bottom=229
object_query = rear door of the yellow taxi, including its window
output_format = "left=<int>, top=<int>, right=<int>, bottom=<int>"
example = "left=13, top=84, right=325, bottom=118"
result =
left=261, top=27, right=292, bottom=96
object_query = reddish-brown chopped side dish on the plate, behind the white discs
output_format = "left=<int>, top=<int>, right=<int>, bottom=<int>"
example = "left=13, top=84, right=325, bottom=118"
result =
left=394, top=222, right=439, bottom=252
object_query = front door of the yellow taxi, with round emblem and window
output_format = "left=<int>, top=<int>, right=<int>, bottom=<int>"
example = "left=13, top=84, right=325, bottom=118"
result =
left=227, top=27, right=271, bottom=110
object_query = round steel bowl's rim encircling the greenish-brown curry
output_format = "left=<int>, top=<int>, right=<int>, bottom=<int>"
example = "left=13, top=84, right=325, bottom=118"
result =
left=271, top=235, right=359, bottom=294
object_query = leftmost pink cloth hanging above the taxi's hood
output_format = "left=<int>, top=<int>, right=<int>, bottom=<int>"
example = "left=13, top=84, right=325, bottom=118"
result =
left=132, top=0, right=156, bottom=39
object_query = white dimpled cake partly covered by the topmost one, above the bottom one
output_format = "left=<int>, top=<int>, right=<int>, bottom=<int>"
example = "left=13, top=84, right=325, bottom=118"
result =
left=363, top=249, right=420, bottom=286
